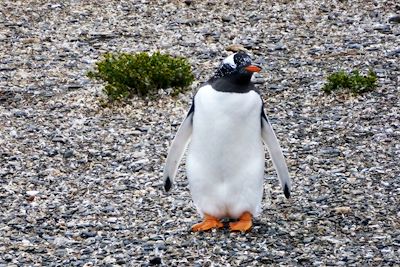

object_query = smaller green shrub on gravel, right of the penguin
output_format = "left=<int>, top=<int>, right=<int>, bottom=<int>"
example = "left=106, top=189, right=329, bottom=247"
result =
left=322, top=70, right=377, bottom=95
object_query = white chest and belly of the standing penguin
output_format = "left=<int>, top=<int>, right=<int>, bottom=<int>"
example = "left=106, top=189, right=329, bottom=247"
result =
left=186, top=85, right=265, bottom=219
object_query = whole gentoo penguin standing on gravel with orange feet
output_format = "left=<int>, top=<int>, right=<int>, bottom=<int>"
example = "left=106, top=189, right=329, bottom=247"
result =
left=163, top=52, right=291, bottom=232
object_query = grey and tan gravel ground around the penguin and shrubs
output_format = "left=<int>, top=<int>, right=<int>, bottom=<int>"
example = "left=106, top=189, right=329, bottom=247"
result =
left=0, top=0, right=400, bottom=266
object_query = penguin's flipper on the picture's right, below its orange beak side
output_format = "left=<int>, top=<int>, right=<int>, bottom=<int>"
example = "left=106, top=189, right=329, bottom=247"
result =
left=261, top=109, right=291, bottom=198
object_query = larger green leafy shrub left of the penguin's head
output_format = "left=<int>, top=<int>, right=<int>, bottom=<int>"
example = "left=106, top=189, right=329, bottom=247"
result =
left=87, top=52, right=194, bottom=100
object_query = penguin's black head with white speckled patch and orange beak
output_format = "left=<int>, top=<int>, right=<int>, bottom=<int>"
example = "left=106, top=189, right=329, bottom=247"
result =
left=213, top=52, right=261, bottom=84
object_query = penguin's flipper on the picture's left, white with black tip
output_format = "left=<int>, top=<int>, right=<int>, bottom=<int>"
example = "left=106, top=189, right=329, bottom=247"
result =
left=163, top=105, right=194, bottom=192
